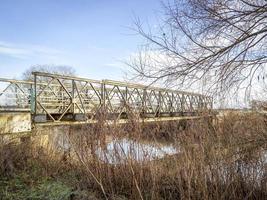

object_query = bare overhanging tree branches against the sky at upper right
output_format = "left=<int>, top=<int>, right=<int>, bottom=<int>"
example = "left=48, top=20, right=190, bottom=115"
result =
left=130, top=0, right=267, bottom=97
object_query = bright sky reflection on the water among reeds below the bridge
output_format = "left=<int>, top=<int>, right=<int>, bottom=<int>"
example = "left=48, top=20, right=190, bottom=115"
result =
left=96, top=138, right=179, bottom=164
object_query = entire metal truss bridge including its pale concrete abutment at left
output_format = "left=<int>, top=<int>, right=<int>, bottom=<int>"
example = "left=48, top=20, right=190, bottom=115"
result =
left=0, top=72, right=213, bottom=133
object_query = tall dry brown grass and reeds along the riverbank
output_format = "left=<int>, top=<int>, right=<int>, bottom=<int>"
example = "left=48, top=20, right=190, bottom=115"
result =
left=0, top=113, right=267, bottom=199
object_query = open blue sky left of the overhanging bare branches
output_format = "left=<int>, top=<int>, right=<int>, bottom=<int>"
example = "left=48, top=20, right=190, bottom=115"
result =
left=0, top=0, right=161, bottom=80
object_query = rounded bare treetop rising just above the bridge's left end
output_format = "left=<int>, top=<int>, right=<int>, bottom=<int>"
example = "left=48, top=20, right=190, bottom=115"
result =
left=22, top=65, right=75, bottom=80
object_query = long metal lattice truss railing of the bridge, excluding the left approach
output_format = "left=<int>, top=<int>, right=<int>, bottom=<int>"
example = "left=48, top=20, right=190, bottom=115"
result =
left=32, top=72, right=212, bottom=121
